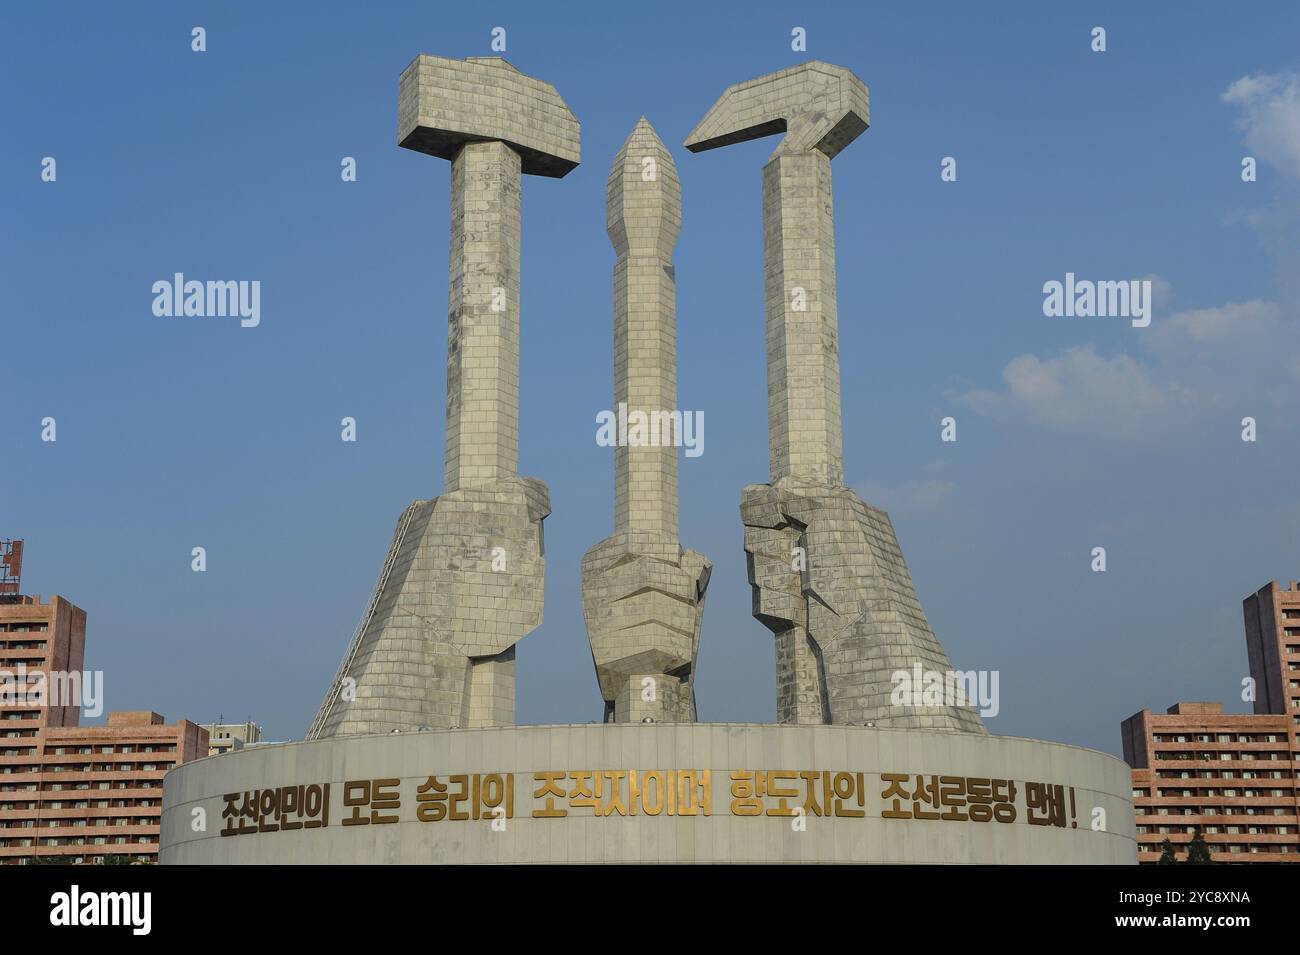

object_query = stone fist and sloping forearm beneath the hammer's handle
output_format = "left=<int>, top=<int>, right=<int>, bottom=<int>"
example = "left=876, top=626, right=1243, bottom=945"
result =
left=313, top=478, right=550, bottom=737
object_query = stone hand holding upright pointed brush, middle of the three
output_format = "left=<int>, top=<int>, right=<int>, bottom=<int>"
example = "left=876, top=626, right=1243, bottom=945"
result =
left=582, top=117, right=712, bottom=722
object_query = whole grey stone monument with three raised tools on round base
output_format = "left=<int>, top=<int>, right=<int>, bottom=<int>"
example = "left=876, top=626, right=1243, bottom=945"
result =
left=160, top=56, right=1138, bottom=864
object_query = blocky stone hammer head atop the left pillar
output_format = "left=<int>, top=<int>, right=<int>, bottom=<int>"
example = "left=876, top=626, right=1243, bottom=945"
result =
left=398, top=55, right=581, bottom=179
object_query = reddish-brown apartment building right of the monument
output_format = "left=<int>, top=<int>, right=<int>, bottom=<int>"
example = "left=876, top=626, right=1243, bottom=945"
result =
left=1121, top=581, right=1300, bottom=863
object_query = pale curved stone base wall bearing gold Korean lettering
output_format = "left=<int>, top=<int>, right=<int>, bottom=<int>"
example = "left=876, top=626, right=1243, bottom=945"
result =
left=161, top=724, right=1136, bottom=864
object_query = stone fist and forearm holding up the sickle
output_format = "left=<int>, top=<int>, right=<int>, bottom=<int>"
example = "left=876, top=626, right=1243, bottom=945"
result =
left=685, top=61, right=985, bottom=733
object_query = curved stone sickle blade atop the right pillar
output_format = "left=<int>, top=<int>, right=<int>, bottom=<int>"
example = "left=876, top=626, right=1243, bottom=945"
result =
left=685, top=60, right=870, bottom=159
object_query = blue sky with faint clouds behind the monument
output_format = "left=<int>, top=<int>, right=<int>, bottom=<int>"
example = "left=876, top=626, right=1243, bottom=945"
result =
left=0, top=3, right=1300, bottom=752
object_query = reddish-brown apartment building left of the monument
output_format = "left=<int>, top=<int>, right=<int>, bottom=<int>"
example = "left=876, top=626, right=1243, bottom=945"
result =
left=0, top=594, right=208, bottom=864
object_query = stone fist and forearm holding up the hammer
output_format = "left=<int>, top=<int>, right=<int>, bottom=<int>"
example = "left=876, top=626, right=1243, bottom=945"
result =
left=308, top=56, right=580, bottom=739
